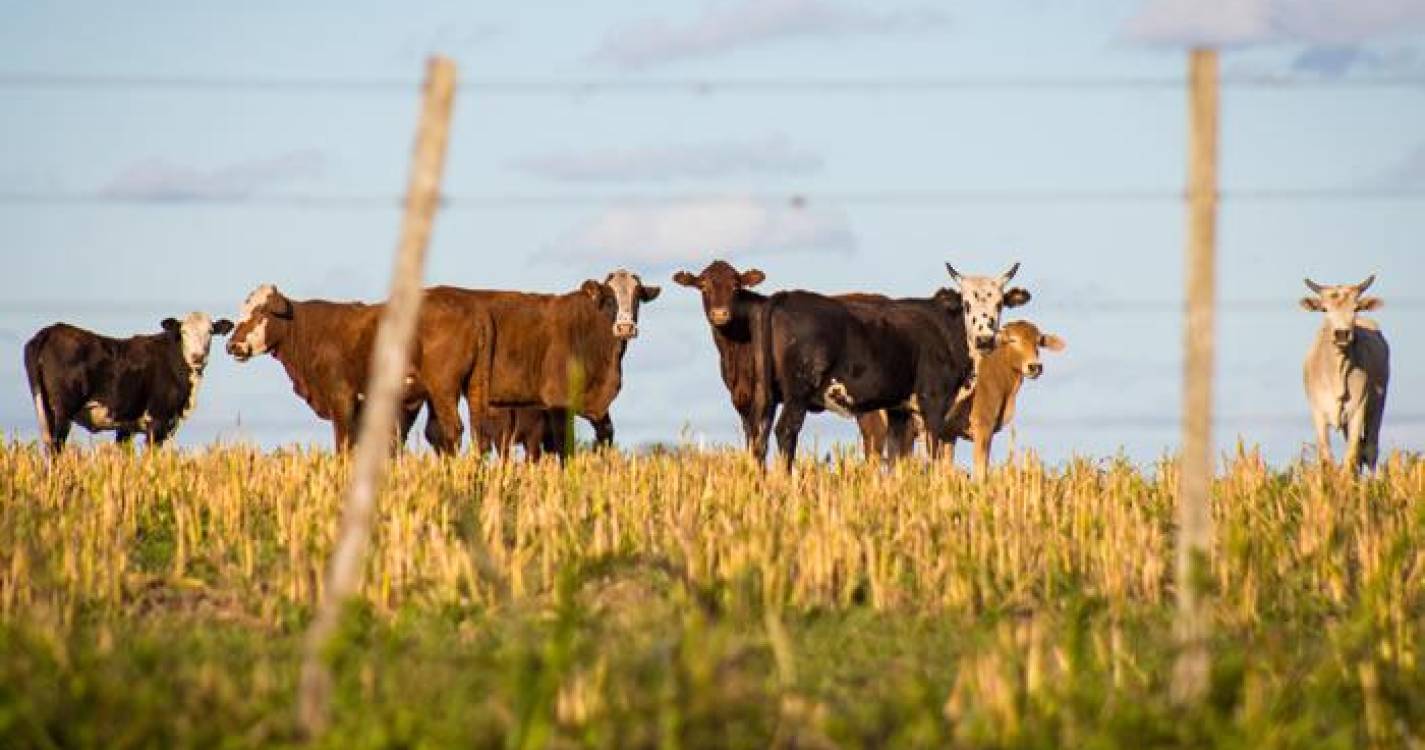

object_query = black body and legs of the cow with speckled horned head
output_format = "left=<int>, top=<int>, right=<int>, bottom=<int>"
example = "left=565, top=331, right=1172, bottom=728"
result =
left=754, top=289, right=972, bottom=471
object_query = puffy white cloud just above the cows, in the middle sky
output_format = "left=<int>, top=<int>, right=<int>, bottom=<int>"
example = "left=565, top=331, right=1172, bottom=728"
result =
left=546, top=197, right=855, bottom=264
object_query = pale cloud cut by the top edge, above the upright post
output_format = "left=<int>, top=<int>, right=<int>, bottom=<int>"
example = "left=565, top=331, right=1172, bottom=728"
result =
left=1126, top=0, right=1425, bottom=47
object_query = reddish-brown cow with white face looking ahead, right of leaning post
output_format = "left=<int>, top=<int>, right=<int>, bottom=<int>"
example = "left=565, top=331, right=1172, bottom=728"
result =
left=419, top=269, right=661, bottom=455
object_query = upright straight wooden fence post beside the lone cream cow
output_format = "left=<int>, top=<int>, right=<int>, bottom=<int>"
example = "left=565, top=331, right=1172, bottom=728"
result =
left=1173, top=48, right=1217, bottom=702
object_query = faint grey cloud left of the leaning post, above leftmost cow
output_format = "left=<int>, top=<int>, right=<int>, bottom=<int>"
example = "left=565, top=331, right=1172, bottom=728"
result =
left=100, top=150, right=328, bottom=201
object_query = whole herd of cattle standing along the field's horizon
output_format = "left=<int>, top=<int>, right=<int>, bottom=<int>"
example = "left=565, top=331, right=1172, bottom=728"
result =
left=16, top=261, right=1389, bottom=476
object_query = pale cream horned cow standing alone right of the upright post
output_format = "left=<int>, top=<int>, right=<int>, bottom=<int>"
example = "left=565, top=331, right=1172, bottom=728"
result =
left=1301, top=275, right=1391, bottom=471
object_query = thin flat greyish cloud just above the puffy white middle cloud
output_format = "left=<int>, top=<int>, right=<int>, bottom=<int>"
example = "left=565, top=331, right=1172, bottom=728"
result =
left=513, top=135, right=822, bottom=183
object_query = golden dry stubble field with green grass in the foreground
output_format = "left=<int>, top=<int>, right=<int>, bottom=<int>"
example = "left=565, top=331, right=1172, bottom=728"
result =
left=0, top=442, right=1425, bottom=747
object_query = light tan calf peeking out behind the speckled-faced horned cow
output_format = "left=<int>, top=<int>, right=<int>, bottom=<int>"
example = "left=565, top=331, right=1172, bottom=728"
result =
left=945, top=321, right=1064, bottom=479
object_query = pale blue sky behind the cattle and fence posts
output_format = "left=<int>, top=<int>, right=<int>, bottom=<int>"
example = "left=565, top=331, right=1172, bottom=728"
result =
left=0, top=0, right=1425, bottom=461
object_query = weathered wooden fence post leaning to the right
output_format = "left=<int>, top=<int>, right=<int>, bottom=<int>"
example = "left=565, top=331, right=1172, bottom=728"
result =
left=298, top=57, right=456, bottom=737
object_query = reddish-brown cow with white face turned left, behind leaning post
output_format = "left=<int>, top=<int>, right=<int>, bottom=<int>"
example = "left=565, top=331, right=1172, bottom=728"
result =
left=228, top=284, right=421, bottom=451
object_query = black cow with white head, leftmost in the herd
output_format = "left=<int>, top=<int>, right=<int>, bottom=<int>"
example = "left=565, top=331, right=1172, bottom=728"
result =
left=24, top=312, right=232, bottom=453
